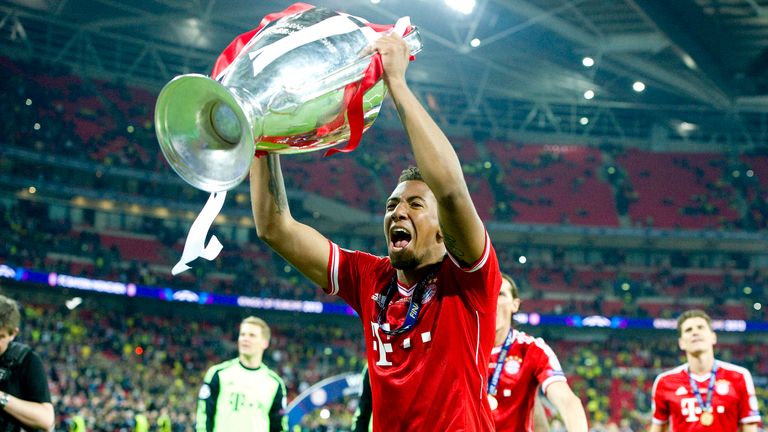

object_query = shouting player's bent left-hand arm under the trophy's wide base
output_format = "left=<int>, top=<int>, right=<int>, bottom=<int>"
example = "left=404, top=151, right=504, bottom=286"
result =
left=250, top=154, right=330, bottom=289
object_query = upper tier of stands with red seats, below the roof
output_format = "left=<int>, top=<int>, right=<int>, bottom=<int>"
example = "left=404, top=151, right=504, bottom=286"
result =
left=0, top=58, right=768, bottom=231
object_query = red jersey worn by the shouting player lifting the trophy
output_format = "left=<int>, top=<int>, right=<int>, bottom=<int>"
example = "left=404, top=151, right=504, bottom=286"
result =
left=328, top=234, right=501, bottom=432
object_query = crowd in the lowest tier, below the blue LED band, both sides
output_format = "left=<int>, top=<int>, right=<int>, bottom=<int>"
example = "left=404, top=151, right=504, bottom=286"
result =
left=0, top=287, right=768, bottom=432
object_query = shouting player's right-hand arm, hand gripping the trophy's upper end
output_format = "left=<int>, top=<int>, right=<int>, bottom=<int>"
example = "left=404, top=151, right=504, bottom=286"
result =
left=374, top=34, right=485, bottom=264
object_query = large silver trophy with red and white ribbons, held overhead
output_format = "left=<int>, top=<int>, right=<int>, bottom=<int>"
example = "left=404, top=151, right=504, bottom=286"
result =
left=155, top=3, right=421, bottom=274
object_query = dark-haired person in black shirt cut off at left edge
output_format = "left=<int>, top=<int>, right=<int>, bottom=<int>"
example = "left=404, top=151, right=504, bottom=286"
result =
left=0, top=295, right=54, bottom=432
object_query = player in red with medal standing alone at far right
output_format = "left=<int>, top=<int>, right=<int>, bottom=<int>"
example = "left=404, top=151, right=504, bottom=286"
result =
left=650, top=309, right=760, bottom=432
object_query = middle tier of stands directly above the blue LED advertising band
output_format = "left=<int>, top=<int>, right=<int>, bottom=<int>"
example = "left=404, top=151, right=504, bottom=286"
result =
left=0, top=196, right=768, bottom=320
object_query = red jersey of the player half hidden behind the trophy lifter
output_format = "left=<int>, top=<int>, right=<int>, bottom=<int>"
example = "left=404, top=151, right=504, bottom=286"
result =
left=488, top=330, right=566, bottom=432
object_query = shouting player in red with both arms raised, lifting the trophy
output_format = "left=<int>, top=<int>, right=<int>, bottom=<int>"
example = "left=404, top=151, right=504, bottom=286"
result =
left=251, top=35, right=501, bottom=432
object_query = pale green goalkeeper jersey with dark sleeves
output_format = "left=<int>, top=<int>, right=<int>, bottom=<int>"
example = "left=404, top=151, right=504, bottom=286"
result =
left=196, top=359, right=288, bottom=432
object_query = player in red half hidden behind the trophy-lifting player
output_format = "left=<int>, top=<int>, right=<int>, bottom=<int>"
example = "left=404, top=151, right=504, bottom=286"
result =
left=488, top=275, right=588, bottom=432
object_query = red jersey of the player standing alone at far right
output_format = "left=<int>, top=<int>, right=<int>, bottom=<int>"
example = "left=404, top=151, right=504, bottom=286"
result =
left=652, top=360, right=760, bottom=432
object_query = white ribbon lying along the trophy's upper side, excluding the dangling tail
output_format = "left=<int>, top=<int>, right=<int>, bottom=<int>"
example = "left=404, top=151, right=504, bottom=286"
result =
left=267, top=26, right=423, bottom=114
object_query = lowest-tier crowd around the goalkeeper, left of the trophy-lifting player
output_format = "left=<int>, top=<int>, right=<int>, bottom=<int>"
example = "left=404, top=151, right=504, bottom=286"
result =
left=12, top=299, right=364, bottom=432
